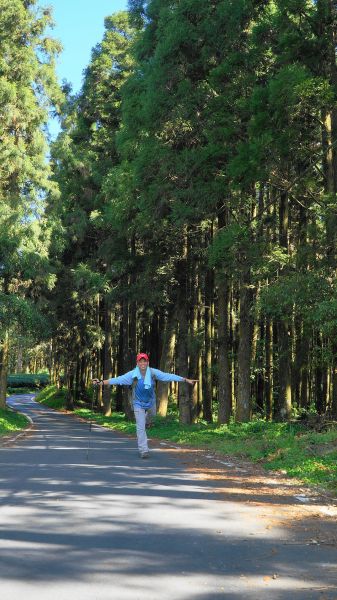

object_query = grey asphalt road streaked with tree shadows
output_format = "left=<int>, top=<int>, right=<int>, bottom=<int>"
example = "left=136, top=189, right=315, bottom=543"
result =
left=0, top=395, right=337, bottom=600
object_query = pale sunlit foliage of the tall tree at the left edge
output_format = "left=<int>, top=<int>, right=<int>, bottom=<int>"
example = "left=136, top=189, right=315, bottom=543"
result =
left=0, top=0, right=62, bottom=360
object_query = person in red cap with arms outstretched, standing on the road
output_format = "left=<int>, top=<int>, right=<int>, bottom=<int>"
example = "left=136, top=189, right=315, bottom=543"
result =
left=93, top=352, right=196, bottom=458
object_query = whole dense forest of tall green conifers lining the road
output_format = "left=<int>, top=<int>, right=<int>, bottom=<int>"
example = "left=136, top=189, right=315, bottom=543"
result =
left=0, top=0, right=337, bottom=424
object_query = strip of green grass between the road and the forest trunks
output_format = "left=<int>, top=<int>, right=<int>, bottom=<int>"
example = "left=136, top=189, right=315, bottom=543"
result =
left=37, top=387, right=337, bottom=493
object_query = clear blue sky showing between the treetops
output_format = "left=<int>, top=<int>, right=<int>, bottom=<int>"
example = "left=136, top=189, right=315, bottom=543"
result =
left=46, top=0, right=127, bottom=137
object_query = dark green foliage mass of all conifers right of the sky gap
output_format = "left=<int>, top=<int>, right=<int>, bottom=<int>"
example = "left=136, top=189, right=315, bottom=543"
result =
left=36, top=0, right=337, bottom=426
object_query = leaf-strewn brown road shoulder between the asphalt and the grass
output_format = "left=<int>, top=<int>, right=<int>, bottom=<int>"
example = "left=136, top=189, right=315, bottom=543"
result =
left=151, top=440, right=337, bottom=547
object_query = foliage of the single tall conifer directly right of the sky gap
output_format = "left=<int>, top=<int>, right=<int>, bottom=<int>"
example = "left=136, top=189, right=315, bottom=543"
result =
left=48, top=12, right=135, bottom=365
